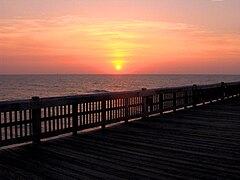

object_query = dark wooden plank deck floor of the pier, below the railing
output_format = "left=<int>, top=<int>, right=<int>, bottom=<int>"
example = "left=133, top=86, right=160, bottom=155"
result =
left=0, top=97, right=240, bottom=179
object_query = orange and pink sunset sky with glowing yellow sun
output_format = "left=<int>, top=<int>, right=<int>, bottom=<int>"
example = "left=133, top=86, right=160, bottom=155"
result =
left=0, top=0, right=240, bottom=74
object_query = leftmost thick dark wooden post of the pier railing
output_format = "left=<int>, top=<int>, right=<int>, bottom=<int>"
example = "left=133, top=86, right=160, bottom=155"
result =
left=32, top=97, right=41, bottom=144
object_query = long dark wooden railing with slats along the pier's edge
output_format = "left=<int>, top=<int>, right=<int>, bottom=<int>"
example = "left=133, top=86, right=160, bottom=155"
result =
left=0, top=82, right=240, bottom=146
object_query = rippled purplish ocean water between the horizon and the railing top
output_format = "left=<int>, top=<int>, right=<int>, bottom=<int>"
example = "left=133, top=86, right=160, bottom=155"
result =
left=0, top=75, right=240, bottom=101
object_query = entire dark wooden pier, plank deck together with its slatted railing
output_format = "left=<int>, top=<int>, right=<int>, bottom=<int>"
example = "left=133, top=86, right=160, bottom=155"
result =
left=0, top=82, right=240, bottom=179
